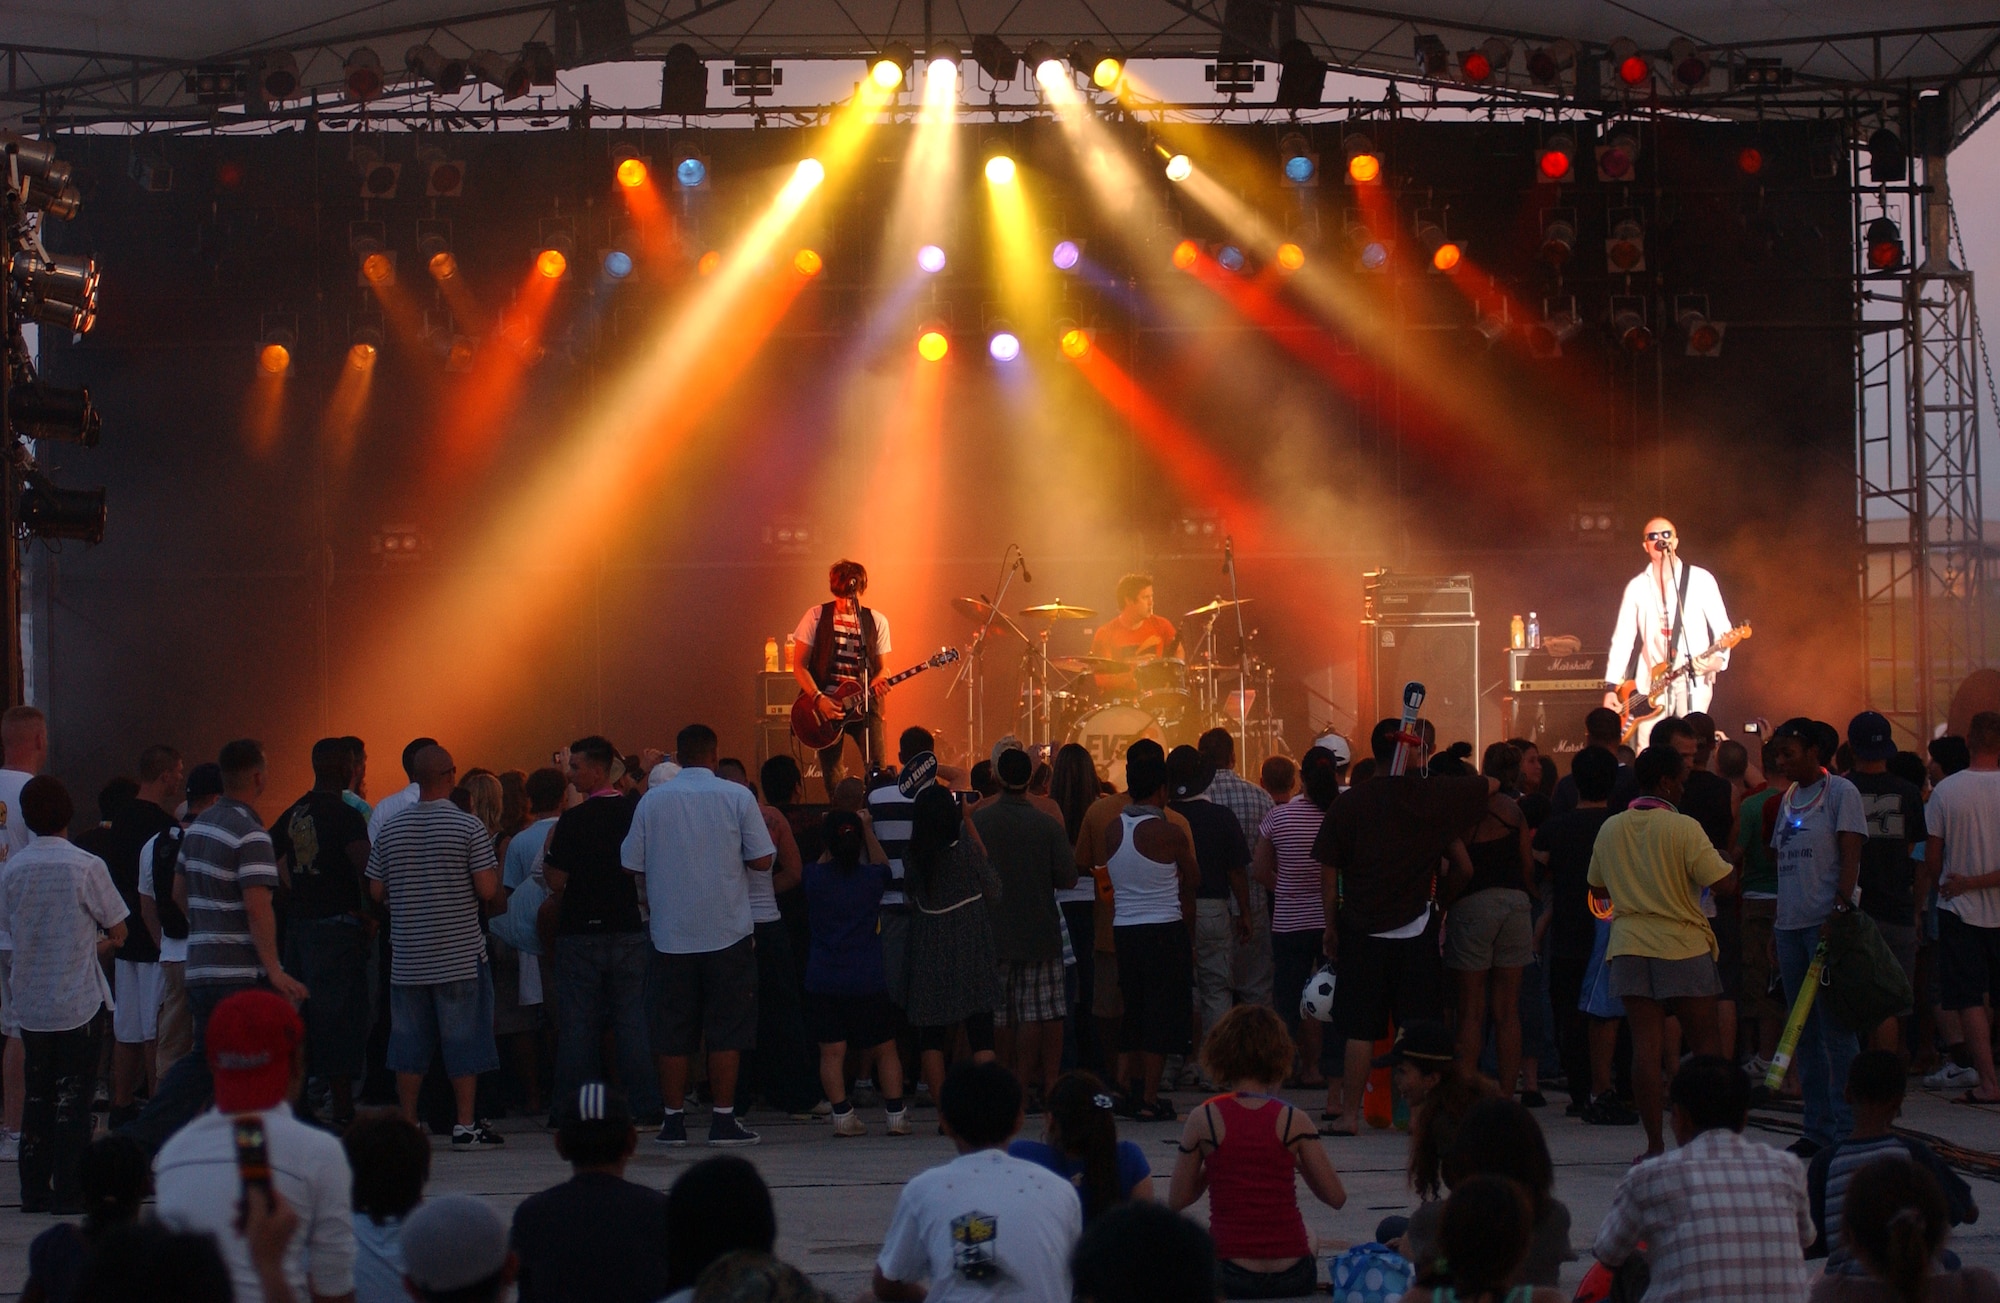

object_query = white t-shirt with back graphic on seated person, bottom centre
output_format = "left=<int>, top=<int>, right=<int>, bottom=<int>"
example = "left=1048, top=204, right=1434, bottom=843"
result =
left=876, top=1149, right=1084, bottom=1303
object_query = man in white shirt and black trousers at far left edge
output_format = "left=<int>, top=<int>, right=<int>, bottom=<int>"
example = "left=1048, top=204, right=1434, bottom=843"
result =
left=0, top=775, right=126, bottom=1217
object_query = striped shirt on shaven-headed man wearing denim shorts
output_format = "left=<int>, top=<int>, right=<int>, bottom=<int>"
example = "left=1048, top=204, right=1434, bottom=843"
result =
left=368, top=799, right=498, bottom=987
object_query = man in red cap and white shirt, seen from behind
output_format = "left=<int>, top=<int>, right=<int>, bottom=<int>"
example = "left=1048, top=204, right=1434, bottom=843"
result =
left=154, top=991, right=354, bottom=1303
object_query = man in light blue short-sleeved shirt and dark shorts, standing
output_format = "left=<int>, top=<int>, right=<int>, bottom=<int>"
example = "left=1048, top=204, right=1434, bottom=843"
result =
left=620, top=723, right=778, bottom=1147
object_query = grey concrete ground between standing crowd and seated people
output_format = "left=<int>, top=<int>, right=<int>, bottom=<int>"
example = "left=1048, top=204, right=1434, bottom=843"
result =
left=0, top=1091, right=2000, bottom=1299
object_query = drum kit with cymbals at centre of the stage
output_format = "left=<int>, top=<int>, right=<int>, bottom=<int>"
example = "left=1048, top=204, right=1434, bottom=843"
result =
left=952, top=598, right=1274, bottom=785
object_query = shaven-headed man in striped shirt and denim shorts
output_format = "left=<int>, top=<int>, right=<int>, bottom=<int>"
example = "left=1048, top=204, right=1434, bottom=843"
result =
left=368, top=743, right=504, bottom=1151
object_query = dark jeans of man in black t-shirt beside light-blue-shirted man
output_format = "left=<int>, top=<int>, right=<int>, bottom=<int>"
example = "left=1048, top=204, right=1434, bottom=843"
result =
left=554, top=931, right=664, bottom=1121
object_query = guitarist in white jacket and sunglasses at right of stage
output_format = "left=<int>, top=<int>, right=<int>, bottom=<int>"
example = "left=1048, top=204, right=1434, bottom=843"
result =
left=1604, top=516, right=1730, bottom=749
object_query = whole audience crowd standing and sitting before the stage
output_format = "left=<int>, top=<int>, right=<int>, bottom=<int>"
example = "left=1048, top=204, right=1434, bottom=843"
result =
left=0, top=691, right=2000, bottom=1303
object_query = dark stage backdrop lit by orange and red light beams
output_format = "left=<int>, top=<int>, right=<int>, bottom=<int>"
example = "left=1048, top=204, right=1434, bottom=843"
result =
left=30, top=122, right=1862, bottom=807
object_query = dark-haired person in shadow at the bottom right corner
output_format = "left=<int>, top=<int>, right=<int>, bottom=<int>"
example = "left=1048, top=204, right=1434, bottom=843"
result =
left=1810, top=1159, right=2000, bottom=1303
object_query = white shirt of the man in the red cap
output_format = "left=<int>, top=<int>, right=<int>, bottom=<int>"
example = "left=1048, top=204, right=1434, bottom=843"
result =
left=152, top=1103, right=354, bottom=1303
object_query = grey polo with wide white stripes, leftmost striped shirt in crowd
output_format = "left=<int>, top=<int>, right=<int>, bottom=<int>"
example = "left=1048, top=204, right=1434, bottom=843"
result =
left=180, top=797, right=278, bottom=987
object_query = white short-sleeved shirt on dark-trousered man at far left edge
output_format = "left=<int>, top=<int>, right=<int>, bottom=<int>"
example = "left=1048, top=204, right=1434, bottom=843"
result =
left=0, top=837, right=128, bottom=1031
